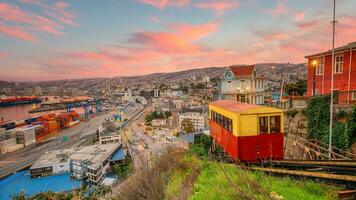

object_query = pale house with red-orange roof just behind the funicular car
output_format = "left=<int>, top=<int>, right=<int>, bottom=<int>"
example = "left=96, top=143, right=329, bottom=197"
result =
left=218, top=65, right=265, bottom=104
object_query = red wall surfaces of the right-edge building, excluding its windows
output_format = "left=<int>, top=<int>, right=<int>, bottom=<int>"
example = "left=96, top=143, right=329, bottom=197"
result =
left=307, top=50, right=356, bottom=103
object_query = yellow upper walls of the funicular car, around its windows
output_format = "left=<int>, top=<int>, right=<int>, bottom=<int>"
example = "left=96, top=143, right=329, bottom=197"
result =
left=209, top=105, right=284, bottom=136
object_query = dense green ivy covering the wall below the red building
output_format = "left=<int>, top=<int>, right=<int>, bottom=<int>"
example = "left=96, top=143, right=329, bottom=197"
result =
left=305, top=95, right=356, bottom=149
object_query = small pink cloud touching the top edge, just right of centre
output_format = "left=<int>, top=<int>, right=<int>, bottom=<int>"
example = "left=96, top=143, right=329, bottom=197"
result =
left=195, top=1, right=238, bottom=16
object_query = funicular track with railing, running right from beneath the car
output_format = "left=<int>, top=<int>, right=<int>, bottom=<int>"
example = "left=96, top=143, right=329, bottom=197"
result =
left=240, top=140, right=356, bottom=188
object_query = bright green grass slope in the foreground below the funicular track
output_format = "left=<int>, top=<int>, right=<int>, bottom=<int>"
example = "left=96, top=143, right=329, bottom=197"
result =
left=189, top=161, right=341, bottom=200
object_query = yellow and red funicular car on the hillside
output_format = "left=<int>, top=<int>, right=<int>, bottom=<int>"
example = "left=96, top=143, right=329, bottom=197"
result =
left=209, top=100, right=284, bottom=162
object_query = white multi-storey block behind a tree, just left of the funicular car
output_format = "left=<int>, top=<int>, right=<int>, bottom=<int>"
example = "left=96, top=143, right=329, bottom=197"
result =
left=178, top=108, right=207, bottom=132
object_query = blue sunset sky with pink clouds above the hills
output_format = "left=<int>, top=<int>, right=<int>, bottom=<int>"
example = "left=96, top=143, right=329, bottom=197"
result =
left=0, top=0, right=356, bottom=81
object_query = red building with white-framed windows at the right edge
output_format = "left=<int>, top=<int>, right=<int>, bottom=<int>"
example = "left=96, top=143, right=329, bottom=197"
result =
left=305, top=42, right=356, bottom=104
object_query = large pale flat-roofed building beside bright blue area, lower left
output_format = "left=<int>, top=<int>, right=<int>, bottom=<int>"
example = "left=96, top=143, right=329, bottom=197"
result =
left=30, top=143, right=121, bottom=185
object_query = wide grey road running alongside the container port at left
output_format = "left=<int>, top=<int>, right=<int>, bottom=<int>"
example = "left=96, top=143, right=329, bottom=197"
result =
left=0, top=103, right=142, bottom=178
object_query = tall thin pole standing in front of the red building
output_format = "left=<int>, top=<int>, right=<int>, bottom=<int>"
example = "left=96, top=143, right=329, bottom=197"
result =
left=329, top=0, right=337, bottom=160
